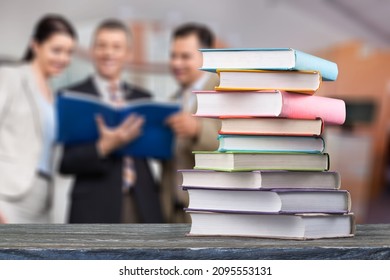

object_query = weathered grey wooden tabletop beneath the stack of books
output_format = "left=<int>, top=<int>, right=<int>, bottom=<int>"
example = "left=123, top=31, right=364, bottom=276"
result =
left=0, top=224, right=390, bottom=260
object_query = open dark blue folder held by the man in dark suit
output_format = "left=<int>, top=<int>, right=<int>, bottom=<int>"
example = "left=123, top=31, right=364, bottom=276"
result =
left=56, top=92, right=180, bottom=159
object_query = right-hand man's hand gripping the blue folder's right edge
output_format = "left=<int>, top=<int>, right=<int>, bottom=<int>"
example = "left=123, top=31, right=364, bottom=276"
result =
left=167, top=112, right=200, bottom=138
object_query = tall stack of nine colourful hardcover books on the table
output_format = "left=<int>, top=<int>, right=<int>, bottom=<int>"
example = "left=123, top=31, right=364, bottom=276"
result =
left=180, top=49, right=355, bottom=239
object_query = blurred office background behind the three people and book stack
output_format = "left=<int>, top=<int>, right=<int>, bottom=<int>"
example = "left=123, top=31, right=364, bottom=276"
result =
left=0, top=0, right=390, bottom=223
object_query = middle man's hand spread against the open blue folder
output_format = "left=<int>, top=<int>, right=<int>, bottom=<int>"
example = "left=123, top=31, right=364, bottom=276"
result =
left=96, top=114, right=144, bottom=156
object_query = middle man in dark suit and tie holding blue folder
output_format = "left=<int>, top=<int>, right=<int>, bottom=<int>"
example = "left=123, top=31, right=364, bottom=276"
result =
left=60, top=20, right=163, bottom=223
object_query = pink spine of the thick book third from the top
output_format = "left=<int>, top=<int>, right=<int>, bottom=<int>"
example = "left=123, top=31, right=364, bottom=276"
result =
left=280, top=92, right=346, bottom=125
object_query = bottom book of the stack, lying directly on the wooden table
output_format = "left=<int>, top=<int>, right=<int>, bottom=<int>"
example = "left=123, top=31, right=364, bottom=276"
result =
left=188, top=211, right=355, bottom=240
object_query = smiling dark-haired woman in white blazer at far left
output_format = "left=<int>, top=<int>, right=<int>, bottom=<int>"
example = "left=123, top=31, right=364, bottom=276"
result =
left=0, top=15, right=76, bottom=223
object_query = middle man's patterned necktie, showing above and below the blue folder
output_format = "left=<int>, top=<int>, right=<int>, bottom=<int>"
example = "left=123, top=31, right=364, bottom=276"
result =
left=108, top=83, right=137, bottom=192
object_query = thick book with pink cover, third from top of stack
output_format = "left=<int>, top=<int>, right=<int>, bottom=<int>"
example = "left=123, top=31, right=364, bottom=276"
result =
left=194, top=90, right=346, bottom=125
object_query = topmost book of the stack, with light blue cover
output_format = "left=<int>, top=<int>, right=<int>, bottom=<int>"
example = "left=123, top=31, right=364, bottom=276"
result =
left=200, top=48, right=338, bottom=81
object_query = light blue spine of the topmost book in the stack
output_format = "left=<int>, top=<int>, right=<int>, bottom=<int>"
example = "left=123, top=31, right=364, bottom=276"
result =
left=294, top=51, right=338, bottom=81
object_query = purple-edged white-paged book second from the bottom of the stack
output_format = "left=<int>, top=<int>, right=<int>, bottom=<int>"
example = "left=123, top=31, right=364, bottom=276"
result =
left=184, top=187, right=351, bottom=213
